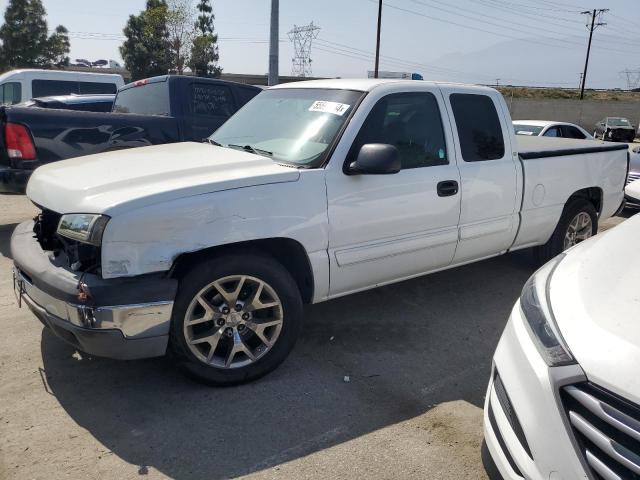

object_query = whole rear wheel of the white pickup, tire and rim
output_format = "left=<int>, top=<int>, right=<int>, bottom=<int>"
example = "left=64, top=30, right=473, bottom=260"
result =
left=535, top=198, right=598, bottom=264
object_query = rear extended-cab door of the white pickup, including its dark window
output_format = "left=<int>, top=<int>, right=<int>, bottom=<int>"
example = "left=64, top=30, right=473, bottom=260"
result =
left=443, top=86, right=519, bottom=263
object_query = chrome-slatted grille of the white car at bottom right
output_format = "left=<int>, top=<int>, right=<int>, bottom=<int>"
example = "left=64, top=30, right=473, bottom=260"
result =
left=561, top=383, right=640, bottom=480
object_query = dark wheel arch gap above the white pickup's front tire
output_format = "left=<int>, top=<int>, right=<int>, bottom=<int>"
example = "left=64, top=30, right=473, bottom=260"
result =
left=169, top=237, right=315, bottom=303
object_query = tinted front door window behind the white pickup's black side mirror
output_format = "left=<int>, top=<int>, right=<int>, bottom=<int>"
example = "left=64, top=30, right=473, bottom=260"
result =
left=348, top=92, right=449, bottom=170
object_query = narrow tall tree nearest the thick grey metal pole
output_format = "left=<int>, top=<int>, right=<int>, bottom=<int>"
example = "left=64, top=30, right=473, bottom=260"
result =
left=189, top=0, right=222, bottom=77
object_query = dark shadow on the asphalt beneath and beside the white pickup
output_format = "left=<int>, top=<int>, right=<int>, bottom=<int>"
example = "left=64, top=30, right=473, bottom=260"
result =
left=41, top=253, right=534, bottom=480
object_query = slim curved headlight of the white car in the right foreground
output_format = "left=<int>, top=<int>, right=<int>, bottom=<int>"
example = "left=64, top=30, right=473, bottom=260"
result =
left=520, top=254, right=576, bottom=367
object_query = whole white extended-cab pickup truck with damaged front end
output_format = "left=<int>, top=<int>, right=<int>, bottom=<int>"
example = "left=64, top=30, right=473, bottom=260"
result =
left=11, top=80, right=628, bottom=385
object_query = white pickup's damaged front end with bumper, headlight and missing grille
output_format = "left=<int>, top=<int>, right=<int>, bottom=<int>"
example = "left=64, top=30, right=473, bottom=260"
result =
left=10, top=209, right=178, bottom=360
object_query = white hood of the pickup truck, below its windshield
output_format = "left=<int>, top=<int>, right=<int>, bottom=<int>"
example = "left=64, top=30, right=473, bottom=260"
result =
left=27, top=142, right=300, bottom=215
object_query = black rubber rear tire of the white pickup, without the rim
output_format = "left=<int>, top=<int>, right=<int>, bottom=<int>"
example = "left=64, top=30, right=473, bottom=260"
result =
left=534, top=198, right=598, bottom=264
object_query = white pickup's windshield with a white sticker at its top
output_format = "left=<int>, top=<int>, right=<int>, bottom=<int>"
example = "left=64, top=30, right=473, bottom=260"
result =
left=209, top=88, right=364, bottom=167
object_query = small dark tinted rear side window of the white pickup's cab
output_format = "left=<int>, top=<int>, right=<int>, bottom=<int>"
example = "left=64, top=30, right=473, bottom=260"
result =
left=450, top=93, right=504, bottom=162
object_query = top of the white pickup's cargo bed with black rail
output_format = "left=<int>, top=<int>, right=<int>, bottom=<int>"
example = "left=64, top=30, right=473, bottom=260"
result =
left=515, top=135, right=629, bottom=160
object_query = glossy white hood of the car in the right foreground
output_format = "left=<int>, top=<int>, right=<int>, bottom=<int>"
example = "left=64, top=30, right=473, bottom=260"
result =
left=550, top=215, right=640, bottom=404
